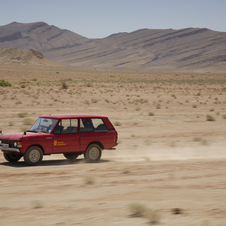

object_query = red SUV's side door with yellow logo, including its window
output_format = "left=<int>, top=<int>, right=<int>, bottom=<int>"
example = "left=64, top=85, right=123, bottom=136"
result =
left=53, top=119, right=80, bottom=153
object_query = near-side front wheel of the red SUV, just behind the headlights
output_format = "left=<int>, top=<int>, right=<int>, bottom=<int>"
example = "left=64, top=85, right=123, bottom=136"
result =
left=24, top=146, right=43, bottom=166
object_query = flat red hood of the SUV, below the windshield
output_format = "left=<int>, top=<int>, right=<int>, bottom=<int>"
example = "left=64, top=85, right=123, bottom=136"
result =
left=0, top=132, right=49, bottom=141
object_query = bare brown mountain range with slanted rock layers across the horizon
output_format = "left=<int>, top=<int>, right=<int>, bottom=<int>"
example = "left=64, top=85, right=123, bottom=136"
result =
left=0, top=22, right=226, bottom=72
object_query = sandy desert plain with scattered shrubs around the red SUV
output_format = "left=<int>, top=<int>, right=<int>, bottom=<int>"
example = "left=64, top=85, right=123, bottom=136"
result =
left=0, top=64, right=226, bottom=226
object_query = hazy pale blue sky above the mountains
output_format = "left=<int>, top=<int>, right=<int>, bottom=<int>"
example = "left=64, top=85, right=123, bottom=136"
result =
left=0, top=0, right=226, bottom=38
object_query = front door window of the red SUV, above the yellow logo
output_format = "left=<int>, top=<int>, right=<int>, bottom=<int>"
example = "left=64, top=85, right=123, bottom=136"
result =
left=54, top=119, right=78, bottom=134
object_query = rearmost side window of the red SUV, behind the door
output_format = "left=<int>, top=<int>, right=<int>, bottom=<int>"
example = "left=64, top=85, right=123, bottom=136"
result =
left=80, top=118, right=108, bottom=133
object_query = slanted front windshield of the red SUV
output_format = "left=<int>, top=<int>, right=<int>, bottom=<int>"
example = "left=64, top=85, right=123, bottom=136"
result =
left=28, top=118, right=58, bottom=133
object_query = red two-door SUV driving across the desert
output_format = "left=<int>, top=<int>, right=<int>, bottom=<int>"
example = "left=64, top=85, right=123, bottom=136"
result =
left=0, top=115, right=118, bottom=165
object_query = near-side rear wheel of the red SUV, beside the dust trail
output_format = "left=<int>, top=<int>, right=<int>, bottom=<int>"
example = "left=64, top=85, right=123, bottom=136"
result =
left=84, top=144, right=102, bottom=162
